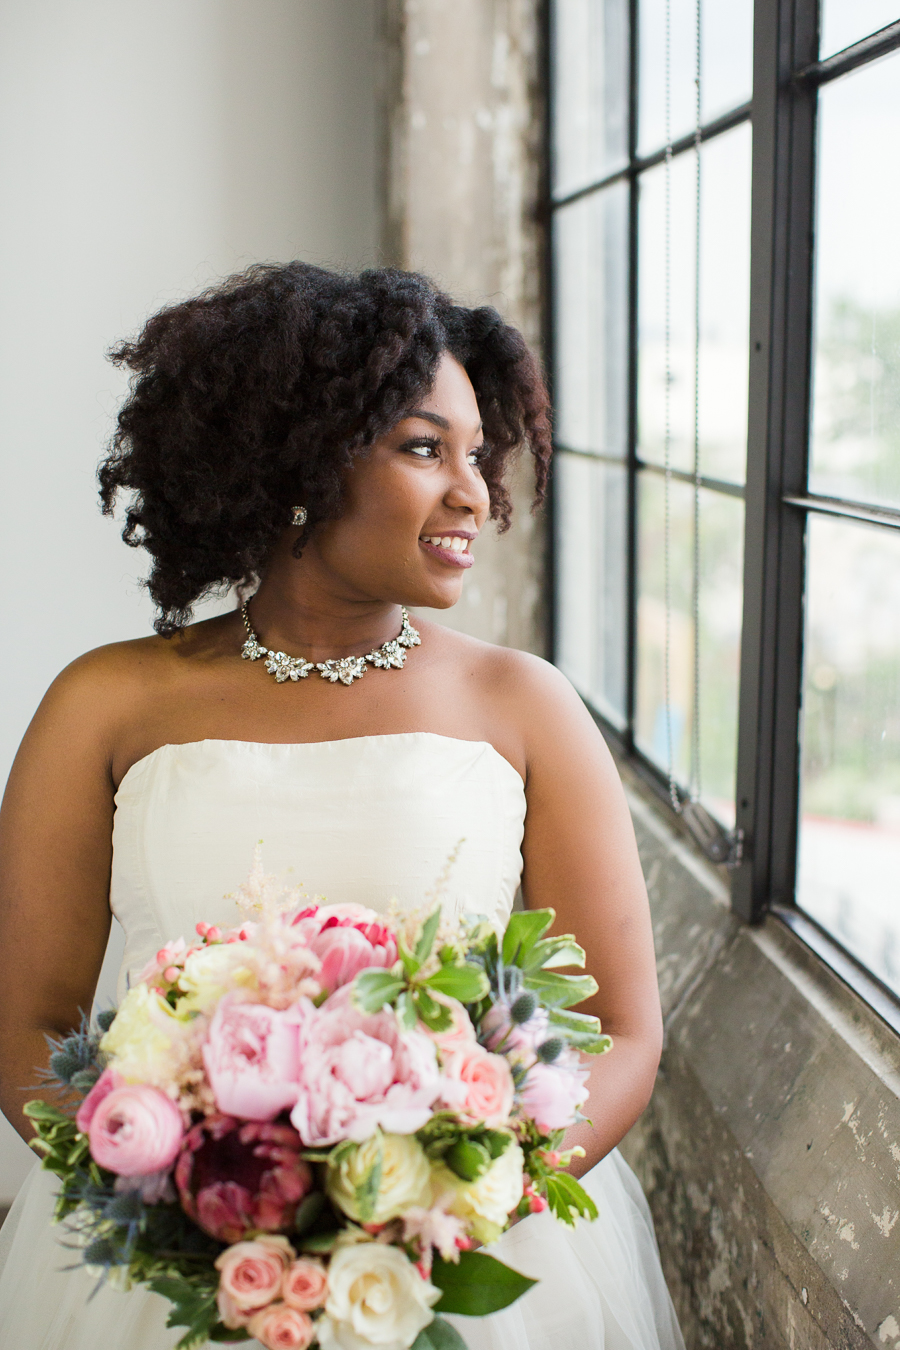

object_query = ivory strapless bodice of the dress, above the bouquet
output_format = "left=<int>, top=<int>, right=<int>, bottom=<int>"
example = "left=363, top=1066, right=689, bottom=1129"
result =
left=111, top=732, right=525, bottom=996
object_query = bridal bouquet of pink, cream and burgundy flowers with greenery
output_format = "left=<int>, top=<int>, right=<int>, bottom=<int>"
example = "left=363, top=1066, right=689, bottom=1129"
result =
left=26, top=865, right=620, bottom=1350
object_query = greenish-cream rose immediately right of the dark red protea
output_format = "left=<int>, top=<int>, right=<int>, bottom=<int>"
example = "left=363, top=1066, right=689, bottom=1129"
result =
left=325, top=1130, right=432, bottom=1223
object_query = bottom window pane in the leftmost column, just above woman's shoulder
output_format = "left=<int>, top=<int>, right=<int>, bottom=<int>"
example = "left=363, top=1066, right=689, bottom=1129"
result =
left=553, top=452, right=627, bottom=726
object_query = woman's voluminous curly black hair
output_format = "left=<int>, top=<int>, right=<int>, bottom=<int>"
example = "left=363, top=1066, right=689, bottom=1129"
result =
left=99, top=262, right=551, bottom=636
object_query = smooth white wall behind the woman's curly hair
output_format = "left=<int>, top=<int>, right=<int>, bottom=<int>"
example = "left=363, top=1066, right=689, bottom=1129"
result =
left=0, top=0, right=379, bottom=1203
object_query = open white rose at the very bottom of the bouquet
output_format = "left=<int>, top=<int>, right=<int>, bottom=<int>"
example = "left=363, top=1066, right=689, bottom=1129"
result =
left=316, top=1242, right=441, bottom=1350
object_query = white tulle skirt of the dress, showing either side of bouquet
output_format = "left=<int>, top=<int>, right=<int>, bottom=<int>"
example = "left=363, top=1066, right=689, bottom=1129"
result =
left=0, top=1152, right=684, bottom=1350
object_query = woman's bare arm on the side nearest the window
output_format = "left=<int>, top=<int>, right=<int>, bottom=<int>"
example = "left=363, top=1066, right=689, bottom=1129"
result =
left=511, top=657, right=663, bottom=1173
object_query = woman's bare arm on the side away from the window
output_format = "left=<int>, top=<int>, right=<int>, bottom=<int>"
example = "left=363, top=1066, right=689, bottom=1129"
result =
left=0, top=653, right=122, bottom=1139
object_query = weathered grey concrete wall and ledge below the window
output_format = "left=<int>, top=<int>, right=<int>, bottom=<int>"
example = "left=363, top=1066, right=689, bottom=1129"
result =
left=622, top=772, right=900, bottom=1350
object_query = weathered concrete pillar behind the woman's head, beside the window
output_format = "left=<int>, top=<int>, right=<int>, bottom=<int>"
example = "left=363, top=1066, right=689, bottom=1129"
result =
left=381, top=0, right=545, bottom=652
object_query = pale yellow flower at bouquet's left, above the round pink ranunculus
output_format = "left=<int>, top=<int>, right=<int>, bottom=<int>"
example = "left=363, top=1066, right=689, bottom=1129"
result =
left=100, top=984, right=192, bottom=1088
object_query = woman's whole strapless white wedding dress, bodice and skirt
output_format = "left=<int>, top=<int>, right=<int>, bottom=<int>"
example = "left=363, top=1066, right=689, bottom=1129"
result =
left=0, top=732, right=683, bottom=1350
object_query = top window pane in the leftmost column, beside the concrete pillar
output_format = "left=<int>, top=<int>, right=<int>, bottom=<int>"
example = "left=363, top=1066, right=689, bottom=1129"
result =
left=552, top=0, right=629, bottom=196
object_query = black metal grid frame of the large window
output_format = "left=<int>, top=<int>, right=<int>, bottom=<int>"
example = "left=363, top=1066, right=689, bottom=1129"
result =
left=546, top=0, right=900, bottom=1031
